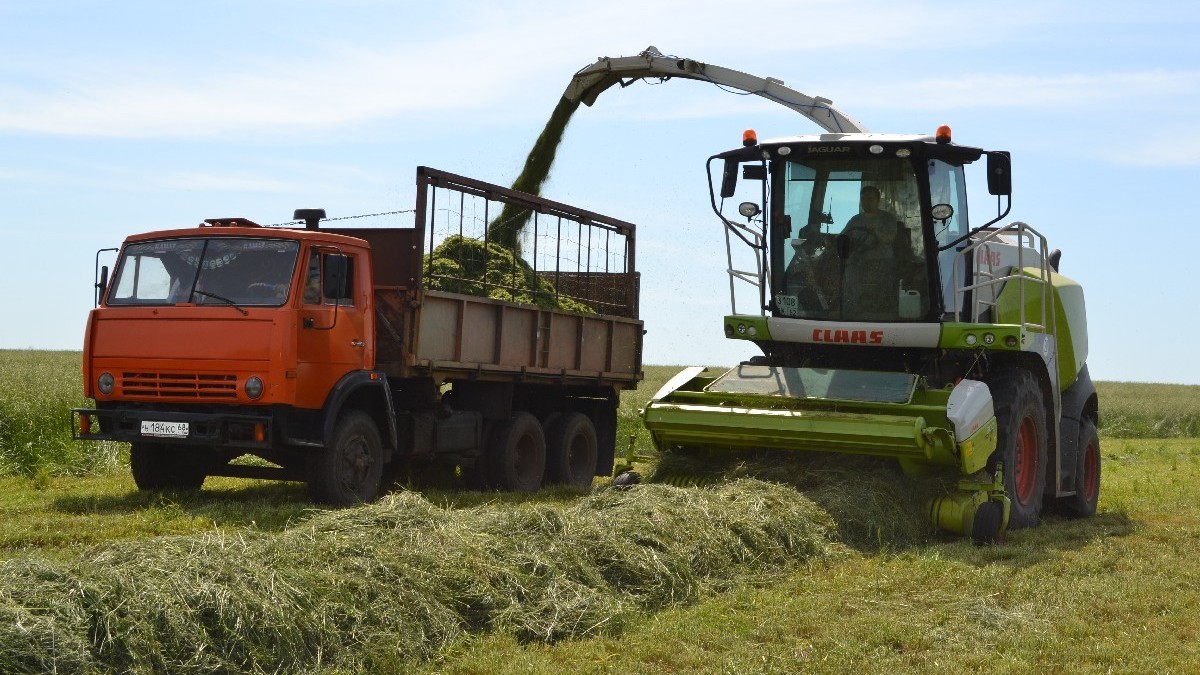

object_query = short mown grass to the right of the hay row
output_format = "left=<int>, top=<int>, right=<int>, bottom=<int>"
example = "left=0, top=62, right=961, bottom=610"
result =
left=418, top=438, right=1200, bottom=674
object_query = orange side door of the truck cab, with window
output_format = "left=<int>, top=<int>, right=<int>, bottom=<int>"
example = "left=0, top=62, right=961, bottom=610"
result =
left=296, top=246, right=371, bottom=408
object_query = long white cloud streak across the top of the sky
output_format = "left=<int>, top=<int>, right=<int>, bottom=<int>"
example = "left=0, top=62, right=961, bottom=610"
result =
left=0, top=0, right=1080, bottom=138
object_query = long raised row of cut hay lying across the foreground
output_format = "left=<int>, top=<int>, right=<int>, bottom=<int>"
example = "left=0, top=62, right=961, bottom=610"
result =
left=0, top=479, right=836, bottom=673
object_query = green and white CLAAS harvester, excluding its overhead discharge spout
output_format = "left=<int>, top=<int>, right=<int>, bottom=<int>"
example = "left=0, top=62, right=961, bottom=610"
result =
left=643, top=114, right=1099, bottom=542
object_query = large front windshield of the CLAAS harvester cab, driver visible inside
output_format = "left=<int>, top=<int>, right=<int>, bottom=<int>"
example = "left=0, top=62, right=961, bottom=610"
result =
left=772, top=156, right=930, bottom=321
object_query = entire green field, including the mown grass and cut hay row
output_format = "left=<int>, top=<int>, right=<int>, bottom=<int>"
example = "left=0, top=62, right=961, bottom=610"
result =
left=0, top=351, right=1200, bottom=673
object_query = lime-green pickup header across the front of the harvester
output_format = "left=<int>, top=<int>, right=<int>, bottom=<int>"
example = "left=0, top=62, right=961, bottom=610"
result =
left=643, top=366, right=995, bottom=473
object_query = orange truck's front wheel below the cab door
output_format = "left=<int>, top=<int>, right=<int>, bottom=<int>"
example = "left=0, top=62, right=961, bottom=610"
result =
left=305, top=411, right=383, bottom=506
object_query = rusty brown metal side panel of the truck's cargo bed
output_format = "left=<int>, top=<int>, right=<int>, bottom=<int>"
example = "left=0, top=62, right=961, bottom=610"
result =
left=413, top=291, right=642, bottom=386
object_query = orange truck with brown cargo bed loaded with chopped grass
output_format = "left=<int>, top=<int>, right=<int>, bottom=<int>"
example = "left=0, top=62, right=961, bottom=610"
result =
left=72, top=167, right=643, bottom=504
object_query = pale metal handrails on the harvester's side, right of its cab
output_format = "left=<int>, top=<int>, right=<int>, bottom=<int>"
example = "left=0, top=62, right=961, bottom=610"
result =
left=952, top=221, right=1055, bottom=333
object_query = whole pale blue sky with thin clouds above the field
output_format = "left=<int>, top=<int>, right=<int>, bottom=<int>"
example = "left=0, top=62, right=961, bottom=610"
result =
left=0, top=0, right=1200, bottom=383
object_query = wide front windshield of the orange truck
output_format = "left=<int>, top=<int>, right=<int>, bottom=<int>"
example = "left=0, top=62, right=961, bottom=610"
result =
left=107, top=237, right=300, bottom=306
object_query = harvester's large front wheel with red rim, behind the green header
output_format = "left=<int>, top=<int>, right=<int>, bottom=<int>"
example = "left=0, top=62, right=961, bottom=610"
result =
left=988, top=370, right=1049, bottom=530
